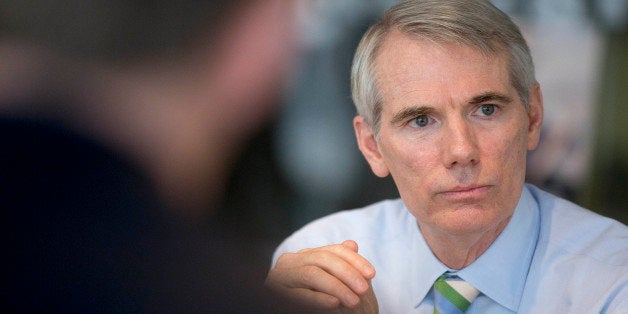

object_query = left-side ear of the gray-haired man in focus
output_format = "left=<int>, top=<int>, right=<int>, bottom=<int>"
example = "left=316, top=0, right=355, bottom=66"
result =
left=353, top=116, right=390, bottom=178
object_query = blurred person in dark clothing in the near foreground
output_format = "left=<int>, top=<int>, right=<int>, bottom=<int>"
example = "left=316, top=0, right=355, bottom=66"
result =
left=0, top=0, right=294, bottom=313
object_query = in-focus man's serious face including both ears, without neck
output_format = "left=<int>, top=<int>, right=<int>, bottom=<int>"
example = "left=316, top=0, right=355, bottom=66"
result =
left=354, top=32, right=542, bottom=235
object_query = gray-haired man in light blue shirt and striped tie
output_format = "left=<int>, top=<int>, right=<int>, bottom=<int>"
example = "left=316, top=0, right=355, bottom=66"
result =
left=267, top=0, right=628, bottom=313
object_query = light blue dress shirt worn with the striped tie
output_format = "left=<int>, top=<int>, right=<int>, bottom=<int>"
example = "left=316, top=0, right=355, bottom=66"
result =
left=273, top=185, right=628, bottom=313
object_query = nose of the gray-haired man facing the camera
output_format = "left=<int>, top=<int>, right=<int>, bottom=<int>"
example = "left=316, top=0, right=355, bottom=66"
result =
left=442, top=118, right=480, bottom=169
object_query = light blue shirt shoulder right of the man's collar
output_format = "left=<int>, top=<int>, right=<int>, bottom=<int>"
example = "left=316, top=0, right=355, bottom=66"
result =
left=520, top=186, right=628, bottom=313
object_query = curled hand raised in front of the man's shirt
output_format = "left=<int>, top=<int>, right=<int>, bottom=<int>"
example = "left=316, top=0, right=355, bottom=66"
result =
left=266, top=240, right=377, bottom=313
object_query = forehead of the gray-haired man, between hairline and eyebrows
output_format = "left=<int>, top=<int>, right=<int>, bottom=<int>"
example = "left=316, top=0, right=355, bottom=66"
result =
left=375, top=31, right=515, bottom=111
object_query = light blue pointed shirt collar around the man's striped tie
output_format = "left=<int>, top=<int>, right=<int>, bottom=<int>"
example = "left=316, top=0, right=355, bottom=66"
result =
left=413, top=187, right=540, bottom=312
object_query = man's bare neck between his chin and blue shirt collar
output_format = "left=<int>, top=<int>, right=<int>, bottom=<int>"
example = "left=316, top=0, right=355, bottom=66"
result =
left=419, top=216, right=512, bottom=269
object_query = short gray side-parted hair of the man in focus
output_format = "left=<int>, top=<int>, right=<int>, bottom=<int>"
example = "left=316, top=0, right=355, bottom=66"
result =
left=351, top=0, right=536, bottom=135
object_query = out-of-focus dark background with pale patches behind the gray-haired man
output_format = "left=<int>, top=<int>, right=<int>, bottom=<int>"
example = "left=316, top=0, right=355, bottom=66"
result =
left=222, top=0, right=628, bottom=262
